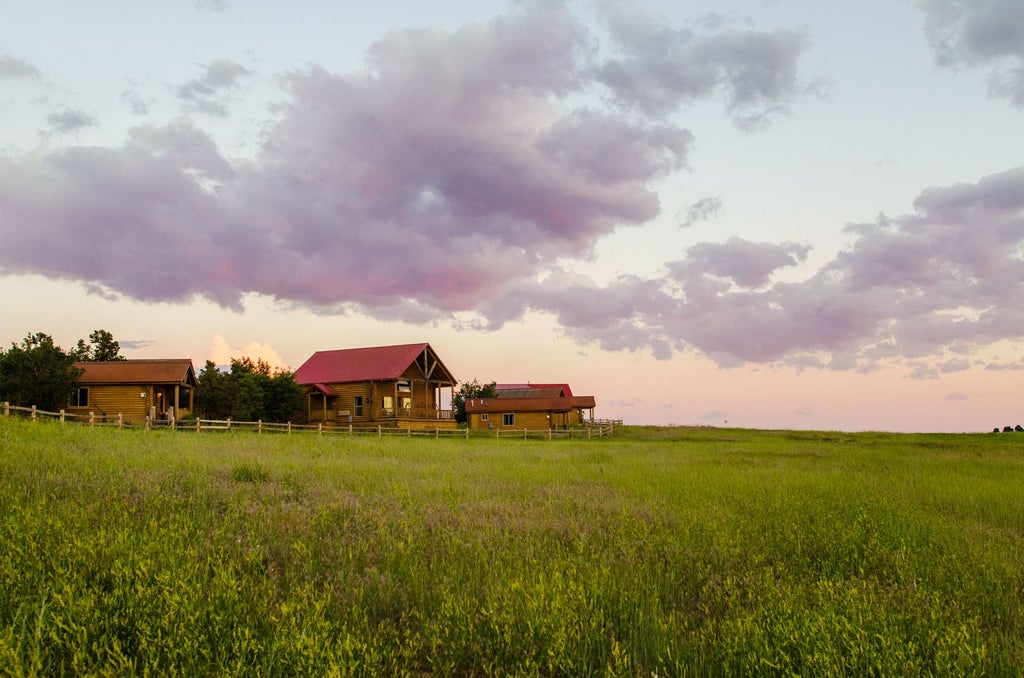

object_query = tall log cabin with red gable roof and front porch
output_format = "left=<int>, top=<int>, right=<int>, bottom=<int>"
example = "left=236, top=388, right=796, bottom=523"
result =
left=295, top=343, right=456, bottom=429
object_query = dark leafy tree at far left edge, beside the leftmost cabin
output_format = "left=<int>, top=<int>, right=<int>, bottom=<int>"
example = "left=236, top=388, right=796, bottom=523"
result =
left=0, top=332, right=82, bottom=412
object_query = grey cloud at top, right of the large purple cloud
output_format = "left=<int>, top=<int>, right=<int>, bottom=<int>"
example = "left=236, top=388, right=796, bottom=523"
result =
left=597, top=0, right=812, bottom=129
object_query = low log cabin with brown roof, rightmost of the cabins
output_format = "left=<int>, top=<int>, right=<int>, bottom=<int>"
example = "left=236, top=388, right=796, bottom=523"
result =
left=466, top=384, right=596, bottom=430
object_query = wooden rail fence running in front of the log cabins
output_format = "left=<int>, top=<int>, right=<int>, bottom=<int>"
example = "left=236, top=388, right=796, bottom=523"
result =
left=2, top=402, right=623, bottom=440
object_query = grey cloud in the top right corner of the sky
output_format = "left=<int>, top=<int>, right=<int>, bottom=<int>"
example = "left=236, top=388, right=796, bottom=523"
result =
left=918, top=0, right=1024, bottom=107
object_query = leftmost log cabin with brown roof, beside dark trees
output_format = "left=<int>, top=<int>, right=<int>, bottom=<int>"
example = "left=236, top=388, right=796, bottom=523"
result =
left=68, top=357, right=196, bottom=421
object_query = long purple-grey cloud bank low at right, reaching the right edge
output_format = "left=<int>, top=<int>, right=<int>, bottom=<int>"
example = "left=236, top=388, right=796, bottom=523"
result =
left=493, top=167, right=1024, bottom=378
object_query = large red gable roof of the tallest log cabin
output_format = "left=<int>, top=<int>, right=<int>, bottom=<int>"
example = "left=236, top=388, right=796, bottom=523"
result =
left=294, top=343, right=455, bottom=385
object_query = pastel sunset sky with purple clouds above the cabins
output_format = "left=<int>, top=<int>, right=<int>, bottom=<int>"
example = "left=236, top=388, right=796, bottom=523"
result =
left=0, top=0, right=1024, bottom=432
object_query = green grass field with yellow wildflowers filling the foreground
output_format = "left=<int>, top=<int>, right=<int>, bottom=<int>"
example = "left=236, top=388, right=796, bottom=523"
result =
left=0, top=418, right=1024, bottom=677
